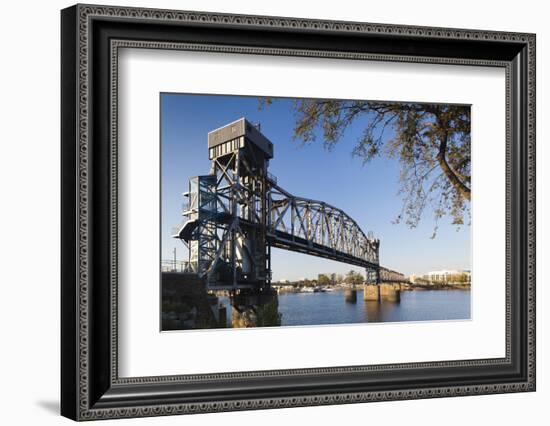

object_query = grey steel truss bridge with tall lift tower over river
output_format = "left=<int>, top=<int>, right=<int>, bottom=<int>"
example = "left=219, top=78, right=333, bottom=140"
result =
left=175, top=118, right=380, bottom=292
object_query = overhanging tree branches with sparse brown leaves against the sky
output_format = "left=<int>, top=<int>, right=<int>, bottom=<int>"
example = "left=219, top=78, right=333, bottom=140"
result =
left=261, top=99, right=471, bottom=238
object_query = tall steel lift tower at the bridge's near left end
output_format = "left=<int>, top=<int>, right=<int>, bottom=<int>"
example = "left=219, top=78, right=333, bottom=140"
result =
left=175, top=118, right=273, bottom=292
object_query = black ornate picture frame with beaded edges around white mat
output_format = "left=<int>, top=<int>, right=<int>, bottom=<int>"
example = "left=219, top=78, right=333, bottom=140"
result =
left=61, top=5, right=535, bottom=420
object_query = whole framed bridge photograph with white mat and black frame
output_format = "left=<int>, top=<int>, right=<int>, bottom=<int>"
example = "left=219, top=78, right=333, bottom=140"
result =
left=61, top=5, right=535, bottom=420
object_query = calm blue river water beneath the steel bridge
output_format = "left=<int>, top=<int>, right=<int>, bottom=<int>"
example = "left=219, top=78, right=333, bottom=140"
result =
left=222, top=290, right=470, bottom=326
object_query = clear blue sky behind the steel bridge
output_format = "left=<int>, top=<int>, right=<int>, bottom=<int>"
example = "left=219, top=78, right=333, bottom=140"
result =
left=160, top=93, right=470, bottom=281
